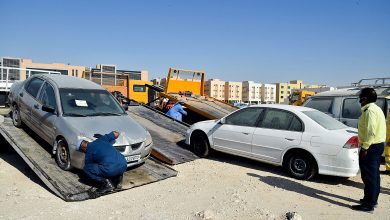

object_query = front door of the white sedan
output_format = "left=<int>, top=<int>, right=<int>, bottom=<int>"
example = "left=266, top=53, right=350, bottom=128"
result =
left=212, top=107, right=263, bottom=155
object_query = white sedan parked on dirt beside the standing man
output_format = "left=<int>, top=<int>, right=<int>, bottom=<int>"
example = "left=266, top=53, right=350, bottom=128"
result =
left=186, top=104, right=359, bottom=179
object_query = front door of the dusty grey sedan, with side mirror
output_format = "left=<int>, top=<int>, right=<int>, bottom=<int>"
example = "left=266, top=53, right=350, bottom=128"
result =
left=31, top=82, right=57, bottom=144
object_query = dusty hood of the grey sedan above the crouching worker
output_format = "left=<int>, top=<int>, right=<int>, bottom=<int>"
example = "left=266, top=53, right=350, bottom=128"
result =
left=64, top=115, right=146, bottom=145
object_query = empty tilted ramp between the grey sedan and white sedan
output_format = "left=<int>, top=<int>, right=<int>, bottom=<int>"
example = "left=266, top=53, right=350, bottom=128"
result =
left=128, top=105, right=198, bottom=165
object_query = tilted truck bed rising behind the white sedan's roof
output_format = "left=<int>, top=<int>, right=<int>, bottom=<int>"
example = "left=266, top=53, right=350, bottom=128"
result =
left=166, top=94, right=238, bottom=119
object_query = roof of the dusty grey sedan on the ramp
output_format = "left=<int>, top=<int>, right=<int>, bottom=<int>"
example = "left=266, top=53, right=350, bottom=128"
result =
left=34, top=74, right=104, bottom=90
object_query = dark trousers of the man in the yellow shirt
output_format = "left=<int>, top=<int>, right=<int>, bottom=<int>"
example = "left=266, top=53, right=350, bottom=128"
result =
left=359, top=143, right=385, bottom=208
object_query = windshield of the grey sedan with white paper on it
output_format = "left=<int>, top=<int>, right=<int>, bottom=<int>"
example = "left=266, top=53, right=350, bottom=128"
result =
left=60, top=89, right=125, bottom=117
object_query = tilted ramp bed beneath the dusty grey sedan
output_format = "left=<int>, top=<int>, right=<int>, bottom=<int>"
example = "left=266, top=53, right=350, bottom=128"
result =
left=0, top=119, right=177, bottom=201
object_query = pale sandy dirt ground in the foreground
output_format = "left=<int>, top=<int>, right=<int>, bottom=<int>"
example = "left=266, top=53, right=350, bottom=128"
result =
left=0, top=140, right=390, bottom=220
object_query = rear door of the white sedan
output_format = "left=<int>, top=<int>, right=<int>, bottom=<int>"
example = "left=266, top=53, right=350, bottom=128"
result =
left=252, top=108, right=303, bottom=163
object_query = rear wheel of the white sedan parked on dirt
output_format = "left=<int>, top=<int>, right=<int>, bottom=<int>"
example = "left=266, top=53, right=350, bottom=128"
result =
left=287, top=152, right=317, bottom=180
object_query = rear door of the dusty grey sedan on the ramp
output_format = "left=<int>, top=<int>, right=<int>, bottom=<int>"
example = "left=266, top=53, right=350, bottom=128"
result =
left=18, top=77, right=43, bottom=128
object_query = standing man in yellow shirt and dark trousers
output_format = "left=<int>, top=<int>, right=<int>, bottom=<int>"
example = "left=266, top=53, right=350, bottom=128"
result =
left=352, top=88, right=386, bottom=212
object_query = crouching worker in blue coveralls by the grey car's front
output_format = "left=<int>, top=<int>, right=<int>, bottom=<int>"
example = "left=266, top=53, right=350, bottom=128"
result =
left=77, top=131, right=127, bottom=194
